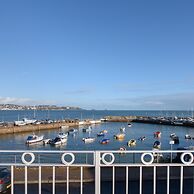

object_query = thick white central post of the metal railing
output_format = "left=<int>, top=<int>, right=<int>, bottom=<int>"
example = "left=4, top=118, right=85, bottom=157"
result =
left=94, top=151, right=101, bottom=194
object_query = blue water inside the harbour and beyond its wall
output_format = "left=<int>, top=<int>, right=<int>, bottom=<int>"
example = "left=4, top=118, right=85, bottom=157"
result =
left=0, top=110, right=194, bottom=150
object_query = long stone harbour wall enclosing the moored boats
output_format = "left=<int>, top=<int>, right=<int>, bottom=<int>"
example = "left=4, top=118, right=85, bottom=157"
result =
left=0, top=116, right=194, bottom=135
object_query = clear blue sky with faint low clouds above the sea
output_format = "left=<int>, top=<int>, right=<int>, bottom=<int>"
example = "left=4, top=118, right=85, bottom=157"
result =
left=0, top=0, right=194, bottom=110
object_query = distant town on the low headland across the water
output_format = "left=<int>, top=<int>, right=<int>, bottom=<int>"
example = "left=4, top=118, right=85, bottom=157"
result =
left=0, top=104, right=81, bottom=110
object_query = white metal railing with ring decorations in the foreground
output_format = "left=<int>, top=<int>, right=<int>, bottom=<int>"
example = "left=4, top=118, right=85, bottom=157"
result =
left=0, top=150, right=194, bottom=194
